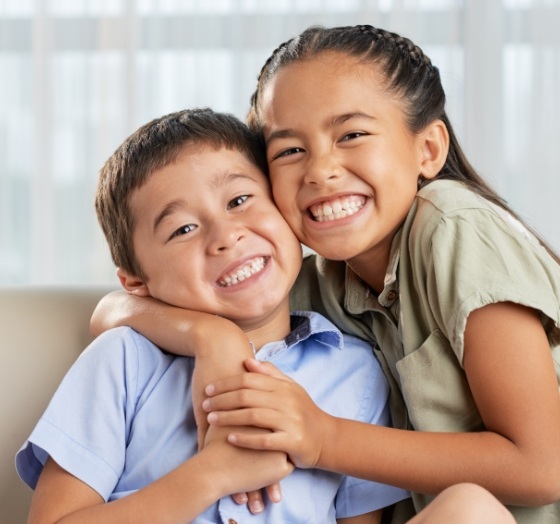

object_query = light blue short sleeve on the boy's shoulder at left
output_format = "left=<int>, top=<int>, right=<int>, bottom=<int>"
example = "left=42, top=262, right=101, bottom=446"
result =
left=16, top=328, right=146, bottom=500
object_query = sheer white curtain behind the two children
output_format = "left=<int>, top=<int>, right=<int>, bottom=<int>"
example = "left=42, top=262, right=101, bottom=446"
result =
left=0, top=0, right=560, bottom=285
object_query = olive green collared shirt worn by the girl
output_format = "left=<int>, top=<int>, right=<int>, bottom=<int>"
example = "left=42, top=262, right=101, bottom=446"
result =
left=291, top=180, right=560, bottom=524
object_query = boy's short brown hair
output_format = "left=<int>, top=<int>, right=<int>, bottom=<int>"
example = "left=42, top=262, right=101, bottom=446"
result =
left=95, top=108, right=268, bottom=280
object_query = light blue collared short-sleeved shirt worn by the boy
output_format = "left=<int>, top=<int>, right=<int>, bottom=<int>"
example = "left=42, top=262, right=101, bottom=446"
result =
left=16, top=312, right=409, bottom=524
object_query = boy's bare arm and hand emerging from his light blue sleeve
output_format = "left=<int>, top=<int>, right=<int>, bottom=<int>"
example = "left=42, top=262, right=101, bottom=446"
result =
left=28, top=440, right=293, bottom=524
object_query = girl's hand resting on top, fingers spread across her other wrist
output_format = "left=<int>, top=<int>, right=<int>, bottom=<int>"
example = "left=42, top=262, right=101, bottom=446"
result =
left=203, top=359, right=335, bottom=468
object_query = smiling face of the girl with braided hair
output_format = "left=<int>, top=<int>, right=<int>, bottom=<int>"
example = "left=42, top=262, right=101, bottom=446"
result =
left=262, top=53, right=429, bottom=284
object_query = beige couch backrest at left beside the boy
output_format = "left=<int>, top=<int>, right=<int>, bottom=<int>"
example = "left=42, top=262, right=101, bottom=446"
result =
left=0, top=288, right=115, bottom=524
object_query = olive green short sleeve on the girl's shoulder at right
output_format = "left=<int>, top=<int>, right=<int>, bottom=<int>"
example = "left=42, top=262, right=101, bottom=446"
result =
left=416, top=203, right=560, bottom=362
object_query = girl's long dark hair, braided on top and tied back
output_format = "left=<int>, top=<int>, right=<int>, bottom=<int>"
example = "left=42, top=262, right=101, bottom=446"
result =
left=247, top=25, right=560, bottom=263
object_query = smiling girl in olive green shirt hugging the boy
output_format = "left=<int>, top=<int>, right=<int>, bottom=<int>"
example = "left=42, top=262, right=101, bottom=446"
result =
left=93, top=26, right=560, bottom=523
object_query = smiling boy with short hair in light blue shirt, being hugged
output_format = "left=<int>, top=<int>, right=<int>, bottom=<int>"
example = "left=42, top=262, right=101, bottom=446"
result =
left=16, top=109, right=408, bottom=523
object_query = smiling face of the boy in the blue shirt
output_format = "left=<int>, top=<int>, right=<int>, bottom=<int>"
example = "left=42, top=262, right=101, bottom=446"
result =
left=120, top=145, right=301, bottom=328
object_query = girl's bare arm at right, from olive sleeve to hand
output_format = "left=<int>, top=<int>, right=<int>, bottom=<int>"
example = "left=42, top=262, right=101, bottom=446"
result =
left=204, top=303, right=560, bottom=506
